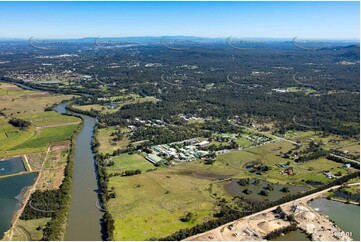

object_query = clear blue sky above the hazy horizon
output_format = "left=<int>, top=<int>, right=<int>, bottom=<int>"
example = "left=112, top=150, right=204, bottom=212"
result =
left=0, top=2, right=360, bottom=39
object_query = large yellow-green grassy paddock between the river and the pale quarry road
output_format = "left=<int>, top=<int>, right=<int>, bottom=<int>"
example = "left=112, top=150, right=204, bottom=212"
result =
left=109, top=162, right=239, bottom=240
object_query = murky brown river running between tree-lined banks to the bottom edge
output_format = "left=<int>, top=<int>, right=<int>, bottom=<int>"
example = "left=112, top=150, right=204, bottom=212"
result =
left=55, top=104, right=103, bottom=241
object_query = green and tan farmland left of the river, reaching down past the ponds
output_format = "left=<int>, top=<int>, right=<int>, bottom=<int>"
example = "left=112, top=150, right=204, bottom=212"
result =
left=0, top=83, right=81, bottom=240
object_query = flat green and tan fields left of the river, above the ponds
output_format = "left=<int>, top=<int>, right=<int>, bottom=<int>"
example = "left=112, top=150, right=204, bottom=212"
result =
left=0, top=83, right=80, bottom=157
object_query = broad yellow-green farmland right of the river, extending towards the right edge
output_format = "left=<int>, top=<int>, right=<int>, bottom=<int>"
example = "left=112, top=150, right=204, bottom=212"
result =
left=97, top=123, right=356, bottom=240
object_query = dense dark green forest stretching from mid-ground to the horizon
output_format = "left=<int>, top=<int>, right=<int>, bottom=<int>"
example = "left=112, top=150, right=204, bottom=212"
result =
left=0, top=41, right=360, bottom=135
